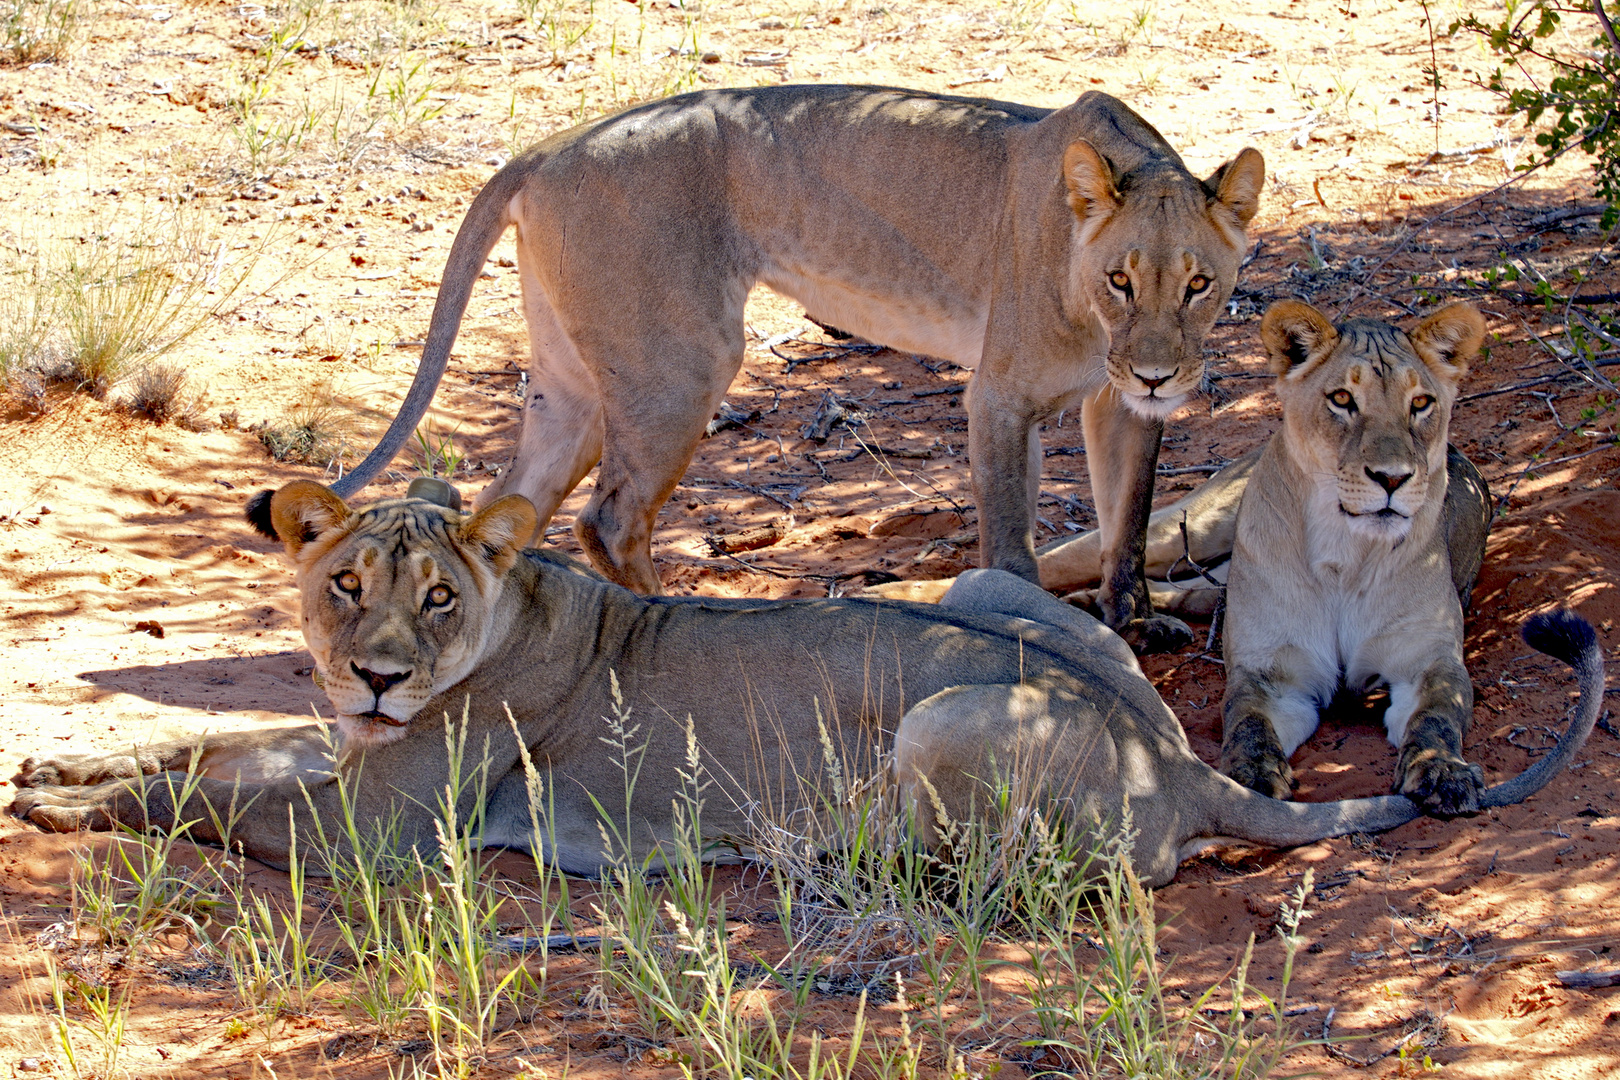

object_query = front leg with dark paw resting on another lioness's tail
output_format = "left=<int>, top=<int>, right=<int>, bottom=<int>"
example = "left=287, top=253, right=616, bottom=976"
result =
left=1383, top=657, right=1486, bottom=818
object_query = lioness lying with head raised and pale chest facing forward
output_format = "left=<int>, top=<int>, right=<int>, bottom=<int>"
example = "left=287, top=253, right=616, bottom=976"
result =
left=1023, top=300, right=1529, bottom=816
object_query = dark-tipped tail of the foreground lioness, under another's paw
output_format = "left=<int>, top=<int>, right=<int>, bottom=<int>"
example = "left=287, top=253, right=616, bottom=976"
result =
left=1213, top=610, right=1604, bottom=847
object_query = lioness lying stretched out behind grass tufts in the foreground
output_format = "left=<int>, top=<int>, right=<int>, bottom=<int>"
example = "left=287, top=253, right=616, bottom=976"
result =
left=11, top=481, right=1602, bottom=884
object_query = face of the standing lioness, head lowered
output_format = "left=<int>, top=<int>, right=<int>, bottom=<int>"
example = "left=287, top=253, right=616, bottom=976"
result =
left=1063, top=139, right=1265, bottom=419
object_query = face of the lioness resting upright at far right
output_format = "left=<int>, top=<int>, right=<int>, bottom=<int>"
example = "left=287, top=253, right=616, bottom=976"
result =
left=1260, top=300, right=1486, bottom=542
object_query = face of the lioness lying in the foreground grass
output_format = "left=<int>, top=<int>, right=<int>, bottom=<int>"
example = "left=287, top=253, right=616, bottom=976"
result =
left=271, top=481, right=536, bottom=746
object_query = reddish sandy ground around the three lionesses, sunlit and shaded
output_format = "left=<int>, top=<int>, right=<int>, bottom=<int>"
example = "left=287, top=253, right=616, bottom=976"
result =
left=0, top=0, right=1620, bottom=1078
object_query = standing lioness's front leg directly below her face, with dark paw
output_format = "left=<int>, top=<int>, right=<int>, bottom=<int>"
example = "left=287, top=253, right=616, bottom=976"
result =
left=1081, top=387, right=1192, bottom=654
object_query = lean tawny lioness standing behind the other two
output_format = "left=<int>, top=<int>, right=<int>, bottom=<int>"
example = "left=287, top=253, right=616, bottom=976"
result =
left=285, top=86, right=1265, bottom=651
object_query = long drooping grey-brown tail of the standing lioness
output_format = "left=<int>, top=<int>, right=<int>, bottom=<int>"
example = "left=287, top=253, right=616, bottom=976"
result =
left=332, top=162, right=523, bottom=499
